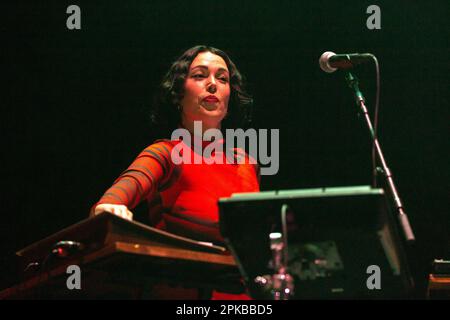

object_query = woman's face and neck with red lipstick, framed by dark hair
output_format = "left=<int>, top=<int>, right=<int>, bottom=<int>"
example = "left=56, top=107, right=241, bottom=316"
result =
left=181, top=52, right=230, bottom=130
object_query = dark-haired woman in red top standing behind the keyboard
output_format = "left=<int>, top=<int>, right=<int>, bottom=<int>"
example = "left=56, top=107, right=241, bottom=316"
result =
left=92, top=46, right=259, bottom=298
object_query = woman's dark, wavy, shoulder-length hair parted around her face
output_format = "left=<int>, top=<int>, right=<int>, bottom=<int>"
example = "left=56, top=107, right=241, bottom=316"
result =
left=150, top=45, right=253, bottom=135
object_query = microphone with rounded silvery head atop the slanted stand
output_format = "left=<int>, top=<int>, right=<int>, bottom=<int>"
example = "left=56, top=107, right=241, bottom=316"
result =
left=319, top=51, right=373, bottom=73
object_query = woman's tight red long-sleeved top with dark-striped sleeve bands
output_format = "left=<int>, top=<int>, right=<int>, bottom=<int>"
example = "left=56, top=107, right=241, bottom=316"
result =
left=94, top=140, right=259, bottom=242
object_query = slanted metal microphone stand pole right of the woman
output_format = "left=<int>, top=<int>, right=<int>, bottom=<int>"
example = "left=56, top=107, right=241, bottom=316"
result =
left=345, top=71, right=415, bottom=243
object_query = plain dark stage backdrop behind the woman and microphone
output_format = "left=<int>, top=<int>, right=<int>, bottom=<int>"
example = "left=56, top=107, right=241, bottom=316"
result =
left=0, top=0, right=450, bottom=296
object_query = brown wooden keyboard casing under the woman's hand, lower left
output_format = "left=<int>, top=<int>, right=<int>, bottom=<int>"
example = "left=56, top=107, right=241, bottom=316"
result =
left=0, top=242, right=243, bottom=299
